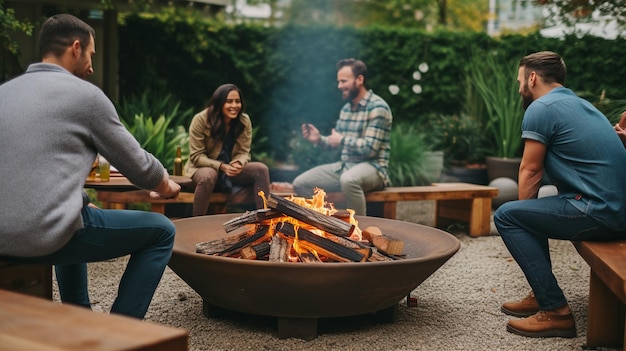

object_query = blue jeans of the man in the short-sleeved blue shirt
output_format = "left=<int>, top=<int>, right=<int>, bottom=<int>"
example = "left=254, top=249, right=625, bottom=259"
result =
left=494, top=196, right=626, bottom=311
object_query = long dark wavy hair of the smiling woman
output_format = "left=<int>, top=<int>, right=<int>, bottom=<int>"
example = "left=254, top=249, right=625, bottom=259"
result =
left=207, top=84, right=246, bottom=140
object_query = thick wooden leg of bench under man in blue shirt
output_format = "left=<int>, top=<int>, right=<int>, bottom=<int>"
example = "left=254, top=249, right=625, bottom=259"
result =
left=587, top=269, right=626, bottom=347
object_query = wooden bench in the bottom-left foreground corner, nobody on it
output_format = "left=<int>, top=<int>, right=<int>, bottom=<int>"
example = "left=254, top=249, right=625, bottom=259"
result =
left=0, top=290, right=189, bottom=351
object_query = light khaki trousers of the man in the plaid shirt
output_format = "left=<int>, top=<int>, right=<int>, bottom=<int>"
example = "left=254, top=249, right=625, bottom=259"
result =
left=293, top=162, right=385, bottom=216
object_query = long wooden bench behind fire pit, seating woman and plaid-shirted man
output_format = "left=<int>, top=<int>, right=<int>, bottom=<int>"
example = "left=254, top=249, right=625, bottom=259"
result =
left=97, top=183, right=498, bottom=236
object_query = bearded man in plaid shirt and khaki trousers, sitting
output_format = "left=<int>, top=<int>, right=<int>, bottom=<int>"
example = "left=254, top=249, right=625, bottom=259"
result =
left=293, top=58, right=392, bottom=215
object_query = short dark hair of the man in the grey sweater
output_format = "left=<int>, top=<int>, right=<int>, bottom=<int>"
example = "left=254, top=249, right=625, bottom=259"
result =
left=39, top=13, right=96, bottom=57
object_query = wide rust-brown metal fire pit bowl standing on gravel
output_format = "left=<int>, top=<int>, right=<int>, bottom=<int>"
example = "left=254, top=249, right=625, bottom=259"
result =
left=169, top=214, right=460, bottom=340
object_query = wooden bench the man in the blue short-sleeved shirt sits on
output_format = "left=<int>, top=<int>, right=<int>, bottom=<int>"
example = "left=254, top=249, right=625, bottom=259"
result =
left=573, top=240, right=626, bottom=351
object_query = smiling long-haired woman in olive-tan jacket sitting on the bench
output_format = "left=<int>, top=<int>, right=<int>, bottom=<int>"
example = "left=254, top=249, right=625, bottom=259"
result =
left=185, top=84, right=270, bottom=216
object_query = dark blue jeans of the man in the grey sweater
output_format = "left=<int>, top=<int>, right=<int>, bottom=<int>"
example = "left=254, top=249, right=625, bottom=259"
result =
left=11, top=207, right=176, bottom=319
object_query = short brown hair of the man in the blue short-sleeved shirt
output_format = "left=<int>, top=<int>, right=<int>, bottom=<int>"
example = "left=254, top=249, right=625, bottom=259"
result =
left=519, top=51, right=567, bottom=85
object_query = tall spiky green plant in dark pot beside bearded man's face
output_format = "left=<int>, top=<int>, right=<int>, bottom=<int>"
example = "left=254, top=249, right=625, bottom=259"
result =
left=468, top=52, right=524, bottom=181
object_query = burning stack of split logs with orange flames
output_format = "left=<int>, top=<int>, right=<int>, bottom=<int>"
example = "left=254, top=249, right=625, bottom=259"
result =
left=196, top=188, right=402, bottom=263
